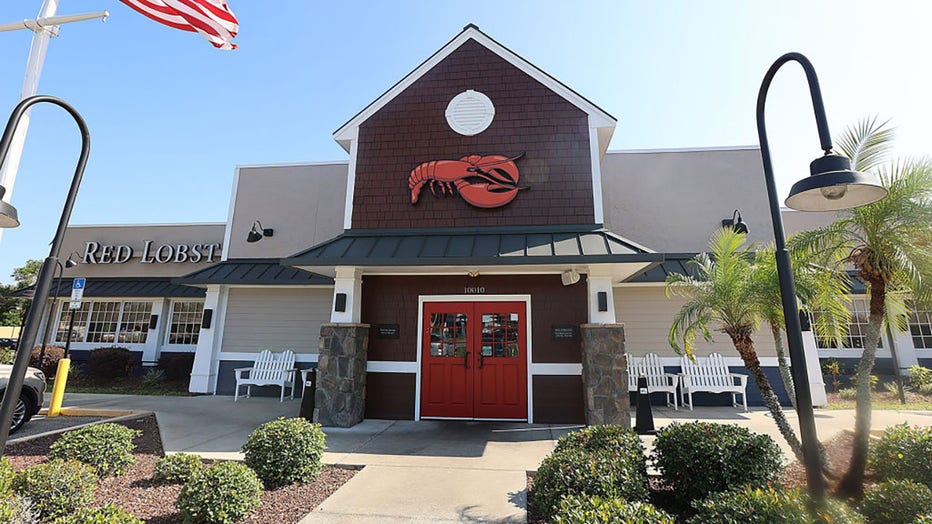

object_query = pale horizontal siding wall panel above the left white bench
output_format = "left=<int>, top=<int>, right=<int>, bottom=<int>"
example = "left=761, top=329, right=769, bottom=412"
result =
left=221, top=288, right=333, bottom=353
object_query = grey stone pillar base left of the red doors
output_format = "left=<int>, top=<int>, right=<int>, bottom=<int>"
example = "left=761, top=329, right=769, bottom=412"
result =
left=314, top=324, right=369, bottom=428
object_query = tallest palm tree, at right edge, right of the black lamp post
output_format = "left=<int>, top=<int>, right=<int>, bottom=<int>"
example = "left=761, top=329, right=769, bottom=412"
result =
left=791, top=119, right=932, bottom=498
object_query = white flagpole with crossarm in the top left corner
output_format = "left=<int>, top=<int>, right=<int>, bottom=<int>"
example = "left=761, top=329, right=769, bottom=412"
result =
left=0, top=0, right=109, bottom=244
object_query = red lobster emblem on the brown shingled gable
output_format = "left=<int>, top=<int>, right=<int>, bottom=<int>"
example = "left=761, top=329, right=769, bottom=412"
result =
left=408, top=153, right=528, bottom=208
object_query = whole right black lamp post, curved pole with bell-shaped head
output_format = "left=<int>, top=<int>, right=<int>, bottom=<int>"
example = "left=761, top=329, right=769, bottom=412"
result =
left=757, top=53, right=887, bottom=500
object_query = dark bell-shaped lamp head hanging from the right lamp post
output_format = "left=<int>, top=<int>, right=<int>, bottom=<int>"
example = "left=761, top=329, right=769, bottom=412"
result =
left=786, top=153, right=887, bottom=211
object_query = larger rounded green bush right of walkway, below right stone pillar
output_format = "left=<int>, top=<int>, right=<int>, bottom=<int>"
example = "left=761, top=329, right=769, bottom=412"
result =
left=530, top=427, right=648, bottom=519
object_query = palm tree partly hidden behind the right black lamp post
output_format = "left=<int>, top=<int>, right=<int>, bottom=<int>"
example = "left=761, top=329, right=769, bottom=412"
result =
left=751, top=244, right=850, bottom=409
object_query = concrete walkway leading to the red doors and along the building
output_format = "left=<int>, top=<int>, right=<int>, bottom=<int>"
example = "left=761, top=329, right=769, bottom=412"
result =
left=56, top=394, right=932, bottom=523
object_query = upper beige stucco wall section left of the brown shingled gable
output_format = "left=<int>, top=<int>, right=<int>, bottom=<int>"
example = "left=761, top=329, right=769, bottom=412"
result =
left=228, top=162, right=347, bottom=258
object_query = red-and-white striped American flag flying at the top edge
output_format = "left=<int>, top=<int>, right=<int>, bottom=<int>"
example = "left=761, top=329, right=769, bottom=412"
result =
left=120, top=0, right=239, bottom=49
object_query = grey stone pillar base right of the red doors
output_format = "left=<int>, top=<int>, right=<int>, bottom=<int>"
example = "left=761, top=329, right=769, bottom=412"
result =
left=580, top=324, right=631, bottom=428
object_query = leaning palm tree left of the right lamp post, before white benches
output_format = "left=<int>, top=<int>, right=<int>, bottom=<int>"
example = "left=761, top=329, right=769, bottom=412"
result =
left=666, top=228, right=802, bottom=462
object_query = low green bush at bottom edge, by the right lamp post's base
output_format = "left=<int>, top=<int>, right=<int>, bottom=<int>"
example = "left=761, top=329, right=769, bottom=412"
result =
left=689, top=486, right=864, bottom=524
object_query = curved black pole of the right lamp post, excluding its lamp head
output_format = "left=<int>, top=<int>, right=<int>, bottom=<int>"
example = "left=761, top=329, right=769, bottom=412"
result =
left=757, top=53, right=832, bottom=500
